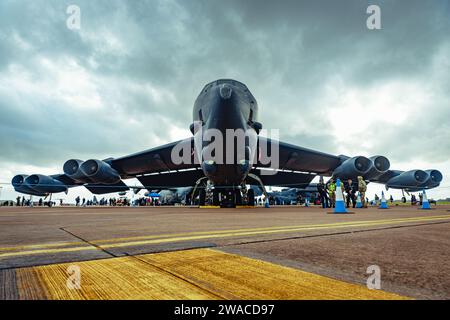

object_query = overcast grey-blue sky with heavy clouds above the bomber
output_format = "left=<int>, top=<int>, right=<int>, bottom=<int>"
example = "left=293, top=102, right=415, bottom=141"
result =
left=0, top=0, right=450, bottom=202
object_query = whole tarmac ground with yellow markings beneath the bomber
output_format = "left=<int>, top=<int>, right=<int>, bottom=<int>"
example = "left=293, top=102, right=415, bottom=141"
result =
left=0, top=206, right=450, bottom=299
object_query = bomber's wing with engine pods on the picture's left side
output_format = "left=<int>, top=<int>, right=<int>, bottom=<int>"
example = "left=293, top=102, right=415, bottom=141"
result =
left=12, top=138, right=201, bottom=196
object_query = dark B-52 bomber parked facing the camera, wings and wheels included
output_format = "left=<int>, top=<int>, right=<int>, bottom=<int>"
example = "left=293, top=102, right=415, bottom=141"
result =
left=12, top=79, right=442, bottom=207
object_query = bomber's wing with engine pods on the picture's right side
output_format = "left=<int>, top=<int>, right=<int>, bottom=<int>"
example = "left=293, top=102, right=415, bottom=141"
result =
left=253, top=137, right=442, bottom=191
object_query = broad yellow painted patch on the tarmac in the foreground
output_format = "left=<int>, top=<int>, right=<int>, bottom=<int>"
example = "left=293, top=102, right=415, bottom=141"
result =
left=16, top=249, right=408, bottom=300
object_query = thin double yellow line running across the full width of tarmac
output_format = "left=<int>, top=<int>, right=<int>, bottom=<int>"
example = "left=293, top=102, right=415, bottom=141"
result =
left=0, top=215, right=450, bottom=259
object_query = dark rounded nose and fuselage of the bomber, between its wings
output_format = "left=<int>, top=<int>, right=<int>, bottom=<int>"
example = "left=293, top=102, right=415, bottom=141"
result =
left=191, top=80, right=260, bottom=187
